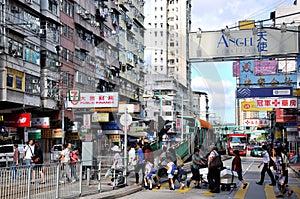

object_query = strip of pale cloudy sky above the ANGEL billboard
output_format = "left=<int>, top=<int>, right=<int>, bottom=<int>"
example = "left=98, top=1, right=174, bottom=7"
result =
left=192, top=0, right=293, bottom=31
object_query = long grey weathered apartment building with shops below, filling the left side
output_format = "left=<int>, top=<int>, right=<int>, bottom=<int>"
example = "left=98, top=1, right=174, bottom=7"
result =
left=0, top=0, right=145, bottom=155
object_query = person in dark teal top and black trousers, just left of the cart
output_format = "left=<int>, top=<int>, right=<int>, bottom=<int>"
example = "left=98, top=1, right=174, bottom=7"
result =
left=186, top=148, right=204, bottom=188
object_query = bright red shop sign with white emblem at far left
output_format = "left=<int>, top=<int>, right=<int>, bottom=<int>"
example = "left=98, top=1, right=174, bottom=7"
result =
left=4, top=113, right=31, bottom=127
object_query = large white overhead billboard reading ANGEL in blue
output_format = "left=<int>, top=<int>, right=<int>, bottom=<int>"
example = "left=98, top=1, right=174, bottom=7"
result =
left=189, top=27, right=299, bottom=61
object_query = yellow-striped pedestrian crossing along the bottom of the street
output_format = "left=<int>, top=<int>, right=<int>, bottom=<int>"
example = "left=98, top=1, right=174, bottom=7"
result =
left=148, top=179, right=300, bottom=199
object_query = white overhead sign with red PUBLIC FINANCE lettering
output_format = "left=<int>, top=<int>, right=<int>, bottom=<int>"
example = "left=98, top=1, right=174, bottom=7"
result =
left=67, top=92, right=119, bottom=108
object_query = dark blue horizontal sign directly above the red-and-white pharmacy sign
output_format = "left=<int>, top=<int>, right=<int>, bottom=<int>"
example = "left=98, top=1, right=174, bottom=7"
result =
left=236, top=87, right=293, bottom=98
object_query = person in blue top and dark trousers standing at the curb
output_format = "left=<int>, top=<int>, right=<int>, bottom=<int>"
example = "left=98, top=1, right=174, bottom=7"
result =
left=135, top=143, right=145, bottom=185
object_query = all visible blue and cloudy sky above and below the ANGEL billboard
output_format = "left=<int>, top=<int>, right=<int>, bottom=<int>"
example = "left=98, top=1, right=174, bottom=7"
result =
left=192, top=0, right=294, bottom=123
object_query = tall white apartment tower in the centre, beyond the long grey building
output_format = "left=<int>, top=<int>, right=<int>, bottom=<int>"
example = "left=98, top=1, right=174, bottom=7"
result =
left=145, top=0, right=192, bottom=127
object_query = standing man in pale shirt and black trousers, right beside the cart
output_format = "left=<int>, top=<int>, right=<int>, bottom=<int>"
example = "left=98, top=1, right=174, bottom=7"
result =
left=207, top=145, right=221, bottom=193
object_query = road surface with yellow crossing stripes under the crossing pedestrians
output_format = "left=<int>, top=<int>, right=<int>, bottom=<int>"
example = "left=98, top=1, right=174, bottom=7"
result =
left=118, top=156, right=300, bottom=199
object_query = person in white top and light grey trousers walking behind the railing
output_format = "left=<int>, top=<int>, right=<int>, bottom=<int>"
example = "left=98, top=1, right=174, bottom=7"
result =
left=60, top=143, right=72, bottom=184
